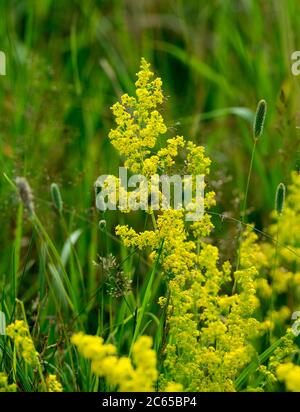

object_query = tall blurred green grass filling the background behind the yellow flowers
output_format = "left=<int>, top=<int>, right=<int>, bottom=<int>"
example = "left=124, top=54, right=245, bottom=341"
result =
left=0, top=0, right=300, bottom=390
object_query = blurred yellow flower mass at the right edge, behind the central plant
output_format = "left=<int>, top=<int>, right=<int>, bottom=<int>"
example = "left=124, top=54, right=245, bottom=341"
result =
left=239, top=172, right=300, bottom=344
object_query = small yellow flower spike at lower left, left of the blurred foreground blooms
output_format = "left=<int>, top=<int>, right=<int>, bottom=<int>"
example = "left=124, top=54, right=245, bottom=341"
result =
left=6, top=320, right=38, bottom=366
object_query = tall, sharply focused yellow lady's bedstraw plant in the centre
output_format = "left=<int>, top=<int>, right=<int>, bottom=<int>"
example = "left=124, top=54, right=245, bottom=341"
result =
left=103, top=59, right=298, bottom=391
